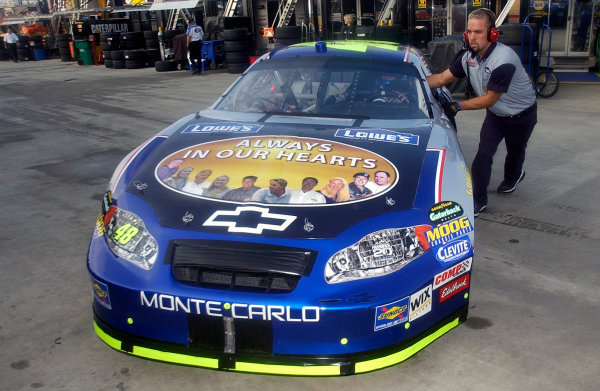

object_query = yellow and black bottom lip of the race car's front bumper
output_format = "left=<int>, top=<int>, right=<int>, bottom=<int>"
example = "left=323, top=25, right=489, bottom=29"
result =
left=94, top=305, right=468, bottom=376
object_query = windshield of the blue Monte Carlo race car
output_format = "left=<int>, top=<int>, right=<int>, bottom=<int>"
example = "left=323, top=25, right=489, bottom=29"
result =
left=215, top=57, right=429, bottom=119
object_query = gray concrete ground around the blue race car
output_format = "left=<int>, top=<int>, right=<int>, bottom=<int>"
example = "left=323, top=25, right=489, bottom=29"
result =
left=0, top=60, right=600, bottom=391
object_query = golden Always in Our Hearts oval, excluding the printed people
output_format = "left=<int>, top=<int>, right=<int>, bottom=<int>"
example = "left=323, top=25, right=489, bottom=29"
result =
left=154, top=136, right=398, bottom=206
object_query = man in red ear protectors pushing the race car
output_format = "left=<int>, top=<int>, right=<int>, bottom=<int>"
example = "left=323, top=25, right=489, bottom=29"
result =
left=427, top=8, right=537, bottom=217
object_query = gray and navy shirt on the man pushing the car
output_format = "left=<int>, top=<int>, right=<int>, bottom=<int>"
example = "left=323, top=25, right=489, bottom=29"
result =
left=450, top=42, right=536, bottom=117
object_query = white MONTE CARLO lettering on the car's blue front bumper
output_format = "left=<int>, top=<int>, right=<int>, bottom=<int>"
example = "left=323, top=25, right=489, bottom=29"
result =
left=140, top=291, right=321, bottom=322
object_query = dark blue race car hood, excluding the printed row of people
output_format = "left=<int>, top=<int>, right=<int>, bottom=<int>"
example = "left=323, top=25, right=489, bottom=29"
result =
left=126, top=118, right=431, bottom=238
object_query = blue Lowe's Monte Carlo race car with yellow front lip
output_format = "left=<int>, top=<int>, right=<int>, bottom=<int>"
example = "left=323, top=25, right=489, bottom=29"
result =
left=88, top=41, right=474, bottom=376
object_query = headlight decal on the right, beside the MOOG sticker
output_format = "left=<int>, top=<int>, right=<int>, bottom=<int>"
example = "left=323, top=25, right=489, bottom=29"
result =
left=325, top=225, right=431, bottom=284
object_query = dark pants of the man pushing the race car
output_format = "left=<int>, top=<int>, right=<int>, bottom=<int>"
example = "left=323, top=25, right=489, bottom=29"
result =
left=471, top=106, right=537, bottom=205
